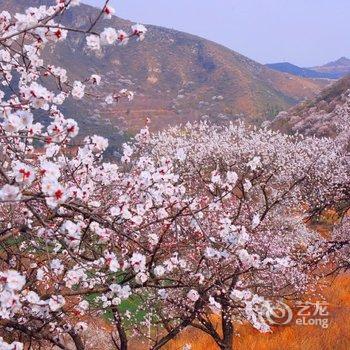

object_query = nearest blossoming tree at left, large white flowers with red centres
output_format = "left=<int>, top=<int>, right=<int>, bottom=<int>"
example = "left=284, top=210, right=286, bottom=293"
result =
left=0, top=0, right=146, bottom=349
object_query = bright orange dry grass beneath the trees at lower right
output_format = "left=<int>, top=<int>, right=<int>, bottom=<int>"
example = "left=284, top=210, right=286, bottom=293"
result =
left=164, top=276, right=350, bottom=350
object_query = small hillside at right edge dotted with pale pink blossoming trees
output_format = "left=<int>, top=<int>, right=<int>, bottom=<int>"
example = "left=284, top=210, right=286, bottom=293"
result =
left=270, top=76, right=350, bottom=137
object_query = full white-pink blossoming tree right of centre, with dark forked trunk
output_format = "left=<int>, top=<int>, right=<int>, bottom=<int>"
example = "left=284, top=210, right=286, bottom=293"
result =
left=123, top=123, right=349, bottom=349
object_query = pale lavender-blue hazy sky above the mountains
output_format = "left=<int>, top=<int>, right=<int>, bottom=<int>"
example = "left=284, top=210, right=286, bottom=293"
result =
left=83, top=0, right=350, bottom=66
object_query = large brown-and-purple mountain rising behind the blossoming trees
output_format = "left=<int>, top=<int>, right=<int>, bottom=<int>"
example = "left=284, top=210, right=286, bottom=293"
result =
left=0, top=0, right=326, bottom=142
